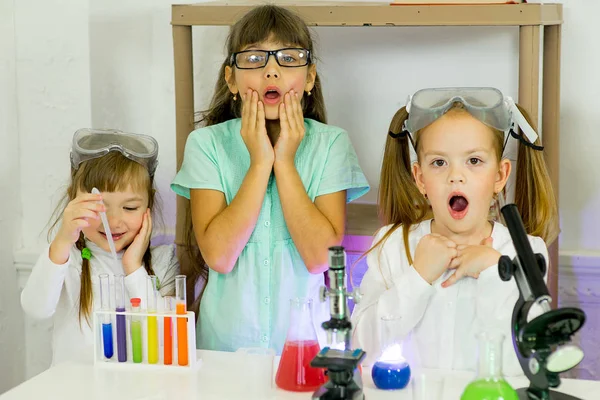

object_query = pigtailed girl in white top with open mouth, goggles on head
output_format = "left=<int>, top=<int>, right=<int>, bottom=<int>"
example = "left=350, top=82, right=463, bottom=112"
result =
left=352, top=88, right=558, bottom=374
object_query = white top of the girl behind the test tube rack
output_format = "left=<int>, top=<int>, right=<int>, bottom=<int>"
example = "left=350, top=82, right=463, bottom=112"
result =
left=21, top=241, right=179, bottom=365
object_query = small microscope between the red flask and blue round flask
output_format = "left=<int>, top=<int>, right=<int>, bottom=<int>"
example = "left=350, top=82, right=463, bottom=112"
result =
left=310, top=246, right=366, bottom=400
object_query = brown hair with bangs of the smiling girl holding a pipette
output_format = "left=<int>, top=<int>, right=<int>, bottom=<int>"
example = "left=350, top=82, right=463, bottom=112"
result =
left=48, top=152, right=156, bottom=325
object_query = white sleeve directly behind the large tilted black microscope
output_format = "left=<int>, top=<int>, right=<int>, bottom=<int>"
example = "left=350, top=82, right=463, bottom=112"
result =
left=474, top=236, right=549, bottom=376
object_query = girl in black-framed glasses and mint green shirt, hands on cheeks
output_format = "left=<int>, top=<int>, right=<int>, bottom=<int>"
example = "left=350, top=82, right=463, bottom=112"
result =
left=171, top=5, right=368, bottom=353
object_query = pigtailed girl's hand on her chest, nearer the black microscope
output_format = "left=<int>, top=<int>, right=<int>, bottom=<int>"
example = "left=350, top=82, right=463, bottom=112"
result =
left=442, top=237, right=501, bottom=287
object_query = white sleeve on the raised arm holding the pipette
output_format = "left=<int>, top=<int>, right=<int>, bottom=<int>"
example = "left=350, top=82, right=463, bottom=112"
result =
left=21, top=246, right=72, bottom=319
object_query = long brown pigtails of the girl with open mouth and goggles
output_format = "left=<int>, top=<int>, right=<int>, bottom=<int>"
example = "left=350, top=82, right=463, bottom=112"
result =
left=365, top=102, right=559, bottom=264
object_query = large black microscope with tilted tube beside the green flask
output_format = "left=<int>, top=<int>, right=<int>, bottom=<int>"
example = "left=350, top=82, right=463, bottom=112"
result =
left=498, top=204, right=585, bottom=400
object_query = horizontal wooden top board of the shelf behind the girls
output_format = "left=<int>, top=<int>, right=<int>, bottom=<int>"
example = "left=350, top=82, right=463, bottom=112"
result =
left=171, top=1, right=563, bottom=26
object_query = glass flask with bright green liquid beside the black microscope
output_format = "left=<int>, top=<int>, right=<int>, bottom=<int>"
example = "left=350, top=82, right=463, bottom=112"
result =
left=460, top=332, right=519, bottom=400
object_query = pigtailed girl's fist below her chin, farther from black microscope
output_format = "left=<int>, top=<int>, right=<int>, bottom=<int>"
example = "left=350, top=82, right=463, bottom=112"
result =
left=413, top=233, right=457, bottom=284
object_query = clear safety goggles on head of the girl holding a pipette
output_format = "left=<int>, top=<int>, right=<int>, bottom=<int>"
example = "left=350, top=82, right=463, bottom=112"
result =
left=71, top=129, right=158, bottom=176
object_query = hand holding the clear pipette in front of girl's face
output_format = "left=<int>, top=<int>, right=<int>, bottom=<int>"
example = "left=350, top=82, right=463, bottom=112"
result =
left=49, top=193, right=106, bottom=264
